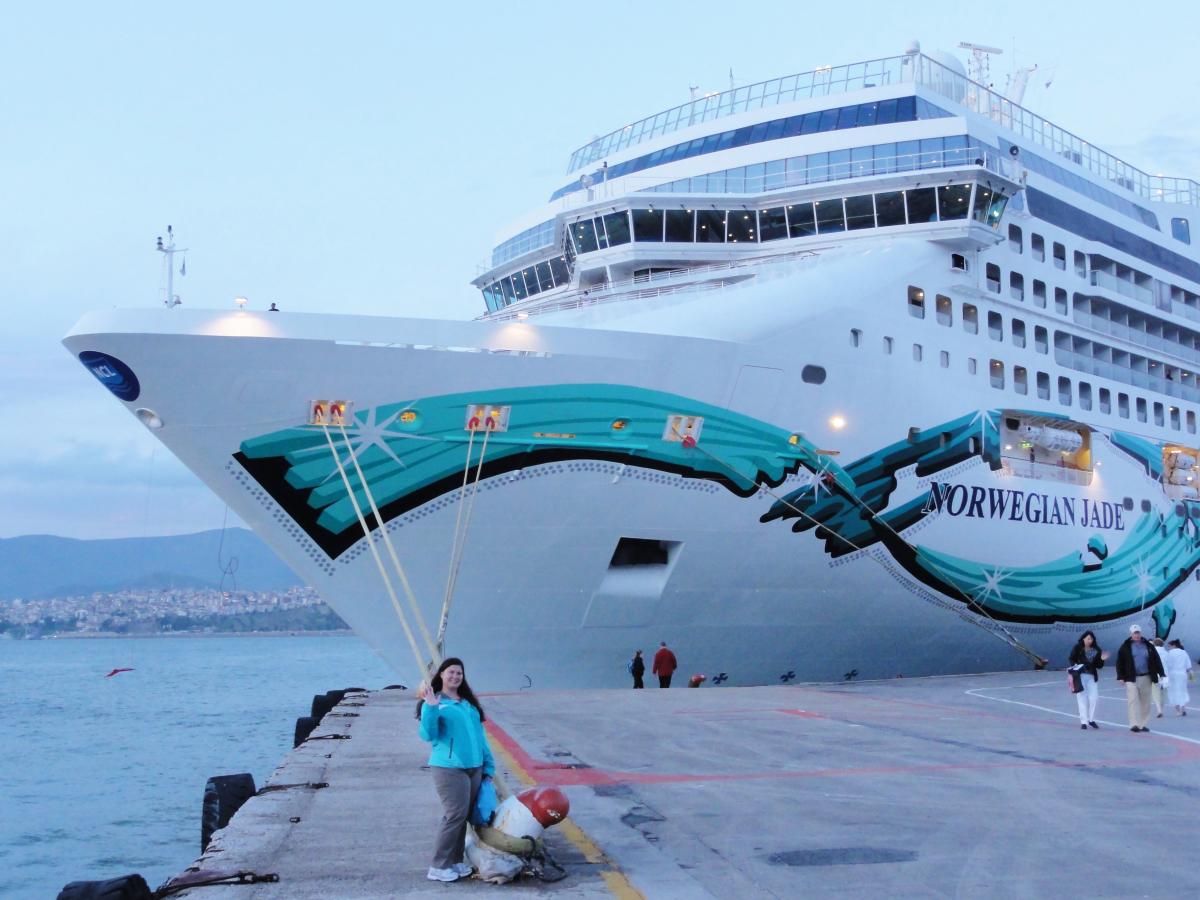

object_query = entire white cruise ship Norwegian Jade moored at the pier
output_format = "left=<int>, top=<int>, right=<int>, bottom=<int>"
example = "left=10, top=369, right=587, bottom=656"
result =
left=64, top=44, right=1200, bottom=690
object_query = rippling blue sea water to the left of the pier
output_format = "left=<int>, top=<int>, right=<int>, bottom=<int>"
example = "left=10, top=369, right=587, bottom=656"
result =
left=0, top=636, right=393, bottom=900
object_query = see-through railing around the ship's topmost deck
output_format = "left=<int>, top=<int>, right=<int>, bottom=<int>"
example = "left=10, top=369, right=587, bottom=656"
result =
left=568, top=53, right=1200, bottom=206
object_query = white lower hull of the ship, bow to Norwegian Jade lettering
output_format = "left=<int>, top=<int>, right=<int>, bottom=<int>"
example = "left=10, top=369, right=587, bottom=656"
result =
left=65, top=242, right=1200, bottom=689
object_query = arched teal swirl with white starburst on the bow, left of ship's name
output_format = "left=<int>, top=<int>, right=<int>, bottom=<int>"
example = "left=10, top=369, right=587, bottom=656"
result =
left=235, top=384, right=830, bottom=557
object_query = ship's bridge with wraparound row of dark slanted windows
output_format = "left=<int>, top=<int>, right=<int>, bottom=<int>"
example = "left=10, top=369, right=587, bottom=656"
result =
left=475, top=138, right=1021, bottom=312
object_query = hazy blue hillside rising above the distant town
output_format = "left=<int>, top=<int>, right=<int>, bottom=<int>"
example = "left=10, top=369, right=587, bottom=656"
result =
left=0, top=528, right=301, bottom=600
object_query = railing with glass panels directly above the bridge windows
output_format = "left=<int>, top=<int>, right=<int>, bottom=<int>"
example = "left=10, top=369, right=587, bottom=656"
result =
left=547, top=146, right=1020, bottom=213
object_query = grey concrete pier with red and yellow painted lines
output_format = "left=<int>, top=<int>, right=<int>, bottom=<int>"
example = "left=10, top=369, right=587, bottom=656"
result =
left=166, top=672, right=1200, bottom=900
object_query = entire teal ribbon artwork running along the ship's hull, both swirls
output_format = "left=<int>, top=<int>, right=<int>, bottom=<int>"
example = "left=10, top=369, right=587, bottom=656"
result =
left=235, top=393, right=1200, bottom=636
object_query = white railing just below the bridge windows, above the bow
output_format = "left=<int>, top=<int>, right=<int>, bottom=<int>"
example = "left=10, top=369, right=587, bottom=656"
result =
left=478, top=250, right=820, bottom=322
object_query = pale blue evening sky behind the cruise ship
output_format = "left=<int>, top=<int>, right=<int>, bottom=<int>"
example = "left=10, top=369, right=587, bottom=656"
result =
left=0, top=0, right=1200, bottom=538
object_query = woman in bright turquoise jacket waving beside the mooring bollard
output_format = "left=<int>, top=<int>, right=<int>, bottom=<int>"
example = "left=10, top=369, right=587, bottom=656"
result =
left=416, top=656, right=496, bottom=881
